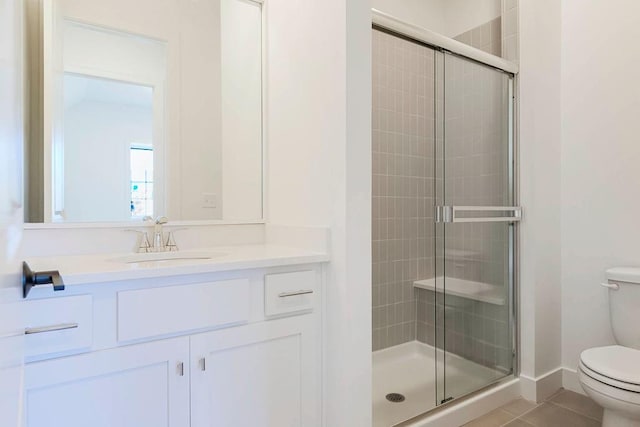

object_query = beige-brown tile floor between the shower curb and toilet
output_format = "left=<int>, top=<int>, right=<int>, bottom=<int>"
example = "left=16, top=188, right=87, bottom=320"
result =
left=465, top=389, right=602, bottom=427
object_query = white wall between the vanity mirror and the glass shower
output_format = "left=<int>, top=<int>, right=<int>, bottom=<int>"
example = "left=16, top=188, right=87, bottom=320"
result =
left=266, top=0, right=371, bottom=427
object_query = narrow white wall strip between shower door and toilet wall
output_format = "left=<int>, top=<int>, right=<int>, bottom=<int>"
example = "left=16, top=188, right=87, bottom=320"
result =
left=519, top=0, right=561, bottom=398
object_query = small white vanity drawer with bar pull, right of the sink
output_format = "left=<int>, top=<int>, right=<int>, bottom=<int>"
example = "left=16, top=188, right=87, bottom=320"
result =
left=264, top=270, right=317, bottom=316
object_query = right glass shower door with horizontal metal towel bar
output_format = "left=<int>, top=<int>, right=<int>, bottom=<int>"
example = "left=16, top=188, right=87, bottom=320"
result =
left=434, top=52, right=521, bottom=404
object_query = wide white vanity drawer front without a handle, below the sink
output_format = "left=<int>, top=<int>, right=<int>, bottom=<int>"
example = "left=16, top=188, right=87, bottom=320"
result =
left=118, top=279, right=251, bottom=341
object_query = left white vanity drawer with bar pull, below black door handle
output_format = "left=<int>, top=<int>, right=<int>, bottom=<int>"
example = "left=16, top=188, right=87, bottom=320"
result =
left=25, top=295, right=93, bottom=357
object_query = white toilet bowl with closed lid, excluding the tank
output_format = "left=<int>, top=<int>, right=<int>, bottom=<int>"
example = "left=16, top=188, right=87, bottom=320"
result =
left=578, top=345, right=640, bottom=427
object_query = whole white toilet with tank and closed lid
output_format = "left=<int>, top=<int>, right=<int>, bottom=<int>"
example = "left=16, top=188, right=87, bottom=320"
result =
left=578, top=268, right=640, bottom=427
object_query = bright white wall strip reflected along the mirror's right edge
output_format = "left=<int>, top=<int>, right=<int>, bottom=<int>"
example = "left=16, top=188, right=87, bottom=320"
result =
left=220, top=0, right=263, bottom=220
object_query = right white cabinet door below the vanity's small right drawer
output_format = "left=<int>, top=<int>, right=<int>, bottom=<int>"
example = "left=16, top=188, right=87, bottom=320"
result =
left=191, top=315, right=321, bottom=427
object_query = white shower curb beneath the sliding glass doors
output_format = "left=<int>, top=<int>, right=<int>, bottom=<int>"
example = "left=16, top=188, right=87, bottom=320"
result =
left=400, top=378, right=520, bottom=427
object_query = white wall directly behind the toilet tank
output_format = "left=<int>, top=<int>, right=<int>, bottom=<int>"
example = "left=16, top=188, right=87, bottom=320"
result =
left=562, top=0, right=640, bottom=369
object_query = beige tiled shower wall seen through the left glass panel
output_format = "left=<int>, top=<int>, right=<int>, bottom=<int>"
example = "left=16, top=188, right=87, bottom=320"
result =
left=372, top=30, right=434, bottom=350
